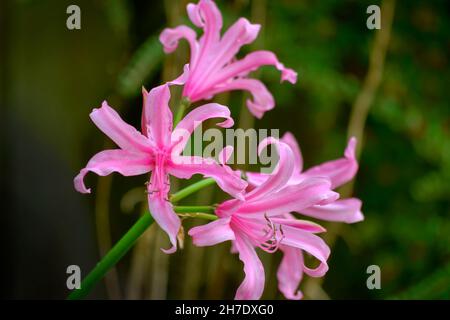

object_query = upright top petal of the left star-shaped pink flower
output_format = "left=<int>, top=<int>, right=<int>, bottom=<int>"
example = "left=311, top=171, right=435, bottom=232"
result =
left=144, top=84, right=173, bottom=147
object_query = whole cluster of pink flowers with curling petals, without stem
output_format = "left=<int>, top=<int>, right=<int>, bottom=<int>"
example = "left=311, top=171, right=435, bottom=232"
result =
left=74, top=0, right=363, bottom=299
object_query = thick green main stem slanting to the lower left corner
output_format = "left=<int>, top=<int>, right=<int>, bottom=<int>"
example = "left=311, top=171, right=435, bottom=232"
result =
left=67, top=214, right=154, bottom=300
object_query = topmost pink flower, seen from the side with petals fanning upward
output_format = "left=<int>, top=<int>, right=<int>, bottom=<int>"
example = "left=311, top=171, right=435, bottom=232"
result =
left=159, top=0, right=297, bottom=118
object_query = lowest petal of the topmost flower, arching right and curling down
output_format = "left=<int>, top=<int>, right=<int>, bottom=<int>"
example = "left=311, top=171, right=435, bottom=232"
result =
left=190, top=79, right=275, bottom=119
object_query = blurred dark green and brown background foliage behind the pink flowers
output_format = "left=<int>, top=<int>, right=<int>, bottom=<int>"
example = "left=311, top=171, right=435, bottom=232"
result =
left=0, top=0, right=450, bottom=299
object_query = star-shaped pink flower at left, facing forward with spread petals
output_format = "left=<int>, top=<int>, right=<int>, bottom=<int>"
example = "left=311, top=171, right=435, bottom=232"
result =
left=74, top=84, right=246, bottom=253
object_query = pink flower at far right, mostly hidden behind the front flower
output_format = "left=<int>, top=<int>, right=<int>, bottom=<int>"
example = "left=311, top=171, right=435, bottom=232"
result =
left=247, top=132, right=364, bottom=299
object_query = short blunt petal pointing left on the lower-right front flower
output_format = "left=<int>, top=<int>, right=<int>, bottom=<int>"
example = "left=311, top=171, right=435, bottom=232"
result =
left=189, top=218, right=235, bottom=247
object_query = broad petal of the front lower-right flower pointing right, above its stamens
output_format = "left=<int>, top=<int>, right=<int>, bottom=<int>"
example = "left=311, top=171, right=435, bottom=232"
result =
left=239, top=177, right=339, bottom=216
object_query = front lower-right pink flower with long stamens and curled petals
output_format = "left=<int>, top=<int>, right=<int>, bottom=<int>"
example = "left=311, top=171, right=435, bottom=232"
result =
left=189, top=138, right=338, bottom=299
